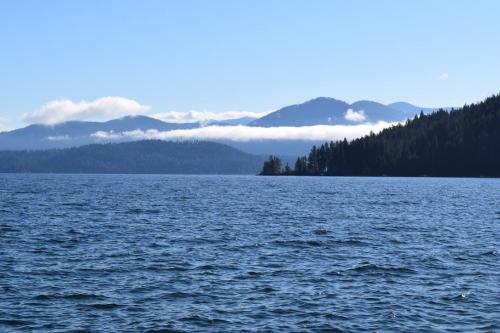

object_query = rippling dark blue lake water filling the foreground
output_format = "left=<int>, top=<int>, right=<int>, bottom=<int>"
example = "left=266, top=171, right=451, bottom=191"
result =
left=0, top=175, right=500, bottom=332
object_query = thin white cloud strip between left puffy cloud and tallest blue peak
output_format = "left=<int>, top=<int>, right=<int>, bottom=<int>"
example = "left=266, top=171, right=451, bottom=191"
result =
left=151, top=110, right=272, bottom=123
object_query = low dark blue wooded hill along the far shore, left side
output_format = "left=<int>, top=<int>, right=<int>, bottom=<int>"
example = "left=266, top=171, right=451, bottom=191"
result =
left=0, top=141, right=264, bottom=174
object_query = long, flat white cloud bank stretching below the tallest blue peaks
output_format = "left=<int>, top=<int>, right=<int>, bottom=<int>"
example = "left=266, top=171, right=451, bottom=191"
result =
left=92, top=121, right=396, bottom=142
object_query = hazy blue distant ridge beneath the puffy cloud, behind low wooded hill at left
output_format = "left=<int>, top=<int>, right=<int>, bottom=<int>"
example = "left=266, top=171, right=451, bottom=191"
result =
left=0, top=116, right=199, bottom=150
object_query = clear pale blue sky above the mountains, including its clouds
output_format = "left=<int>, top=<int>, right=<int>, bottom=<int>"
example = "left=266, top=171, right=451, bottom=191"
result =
left=0, top=0, right=500, bottom=130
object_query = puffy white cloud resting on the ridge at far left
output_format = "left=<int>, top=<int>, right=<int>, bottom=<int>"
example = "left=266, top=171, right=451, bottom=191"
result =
left=22, top=97, right=149, bottom=125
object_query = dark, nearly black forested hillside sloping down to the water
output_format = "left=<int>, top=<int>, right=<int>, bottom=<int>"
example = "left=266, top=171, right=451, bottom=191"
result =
left=263, top=94, right=500, bottom=177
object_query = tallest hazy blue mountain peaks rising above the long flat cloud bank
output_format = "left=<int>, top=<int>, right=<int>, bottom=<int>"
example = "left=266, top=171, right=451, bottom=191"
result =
left=250, top=97, right=444, bottom=127
